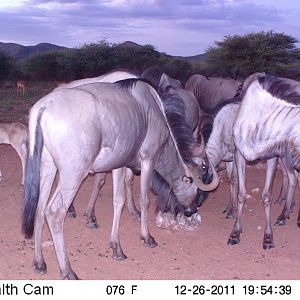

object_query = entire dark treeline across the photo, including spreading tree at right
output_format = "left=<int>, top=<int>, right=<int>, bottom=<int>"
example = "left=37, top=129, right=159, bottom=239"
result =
left=0, top=31, right=300, bottom=82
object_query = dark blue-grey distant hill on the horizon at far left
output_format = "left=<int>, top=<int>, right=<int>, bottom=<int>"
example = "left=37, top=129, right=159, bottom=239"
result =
left=0, top=42, right=67, bottom=59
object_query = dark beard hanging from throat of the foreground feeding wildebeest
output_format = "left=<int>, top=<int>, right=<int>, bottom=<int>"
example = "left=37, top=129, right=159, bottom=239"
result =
left=151, top=170, right=185, bottom=214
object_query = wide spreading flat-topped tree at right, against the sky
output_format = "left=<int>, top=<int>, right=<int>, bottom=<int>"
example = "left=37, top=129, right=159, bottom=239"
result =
left=206, top=31, right=300, bottom=77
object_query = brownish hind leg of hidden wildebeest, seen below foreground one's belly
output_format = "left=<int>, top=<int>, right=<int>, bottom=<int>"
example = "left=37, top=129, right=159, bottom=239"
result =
left=84, top=173, right=106, bottom=228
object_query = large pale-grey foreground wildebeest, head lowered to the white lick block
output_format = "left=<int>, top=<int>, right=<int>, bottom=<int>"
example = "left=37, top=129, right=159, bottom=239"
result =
left=22, top=79, right=218, bottom=279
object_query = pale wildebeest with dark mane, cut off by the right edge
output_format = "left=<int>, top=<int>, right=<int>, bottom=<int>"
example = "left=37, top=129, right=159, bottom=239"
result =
left=228, top=75, right=300, bottom=249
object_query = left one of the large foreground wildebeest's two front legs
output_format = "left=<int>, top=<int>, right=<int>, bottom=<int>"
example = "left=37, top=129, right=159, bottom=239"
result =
left=110, top=167, right=127, bottom=260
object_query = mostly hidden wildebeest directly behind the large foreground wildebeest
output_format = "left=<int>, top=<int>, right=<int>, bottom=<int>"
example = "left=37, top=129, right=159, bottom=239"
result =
left=63, top=70, right=207, bottom=228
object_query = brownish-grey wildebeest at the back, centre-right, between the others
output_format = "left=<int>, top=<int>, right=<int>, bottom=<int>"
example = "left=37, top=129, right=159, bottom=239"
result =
left=185, top=74, right=242, bottom=142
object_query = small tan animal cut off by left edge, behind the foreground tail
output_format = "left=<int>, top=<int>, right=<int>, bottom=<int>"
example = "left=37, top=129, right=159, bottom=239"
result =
left=0, top=122, right=28, bottom=185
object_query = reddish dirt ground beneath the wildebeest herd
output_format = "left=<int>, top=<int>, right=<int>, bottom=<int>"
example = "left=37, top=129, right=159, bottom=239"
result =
left=0, top=145, right=300, bottom=280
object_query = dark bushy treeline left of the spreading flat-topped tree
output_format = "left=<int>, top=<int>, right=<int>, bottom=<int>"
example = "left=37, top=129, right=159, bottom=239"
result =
left=0, top=41, right=193, bottom=81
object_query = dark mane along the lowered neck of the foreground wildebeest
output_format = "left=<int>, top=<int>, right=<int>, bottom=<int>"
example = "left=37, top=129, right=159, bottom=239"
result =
left=162, top=93, right=196, bottom=165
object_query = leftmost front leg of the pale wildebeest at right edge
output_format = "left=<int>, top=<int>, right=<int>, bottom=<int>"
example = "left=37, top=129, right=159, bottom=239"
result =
left=228, top=150, right=246, bottom=245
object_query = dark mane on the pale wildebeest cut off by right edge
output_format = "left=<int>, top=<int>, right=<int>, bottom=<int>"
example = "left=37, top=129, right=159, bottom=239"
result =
left=258, top=75, right=300, bottom=105
